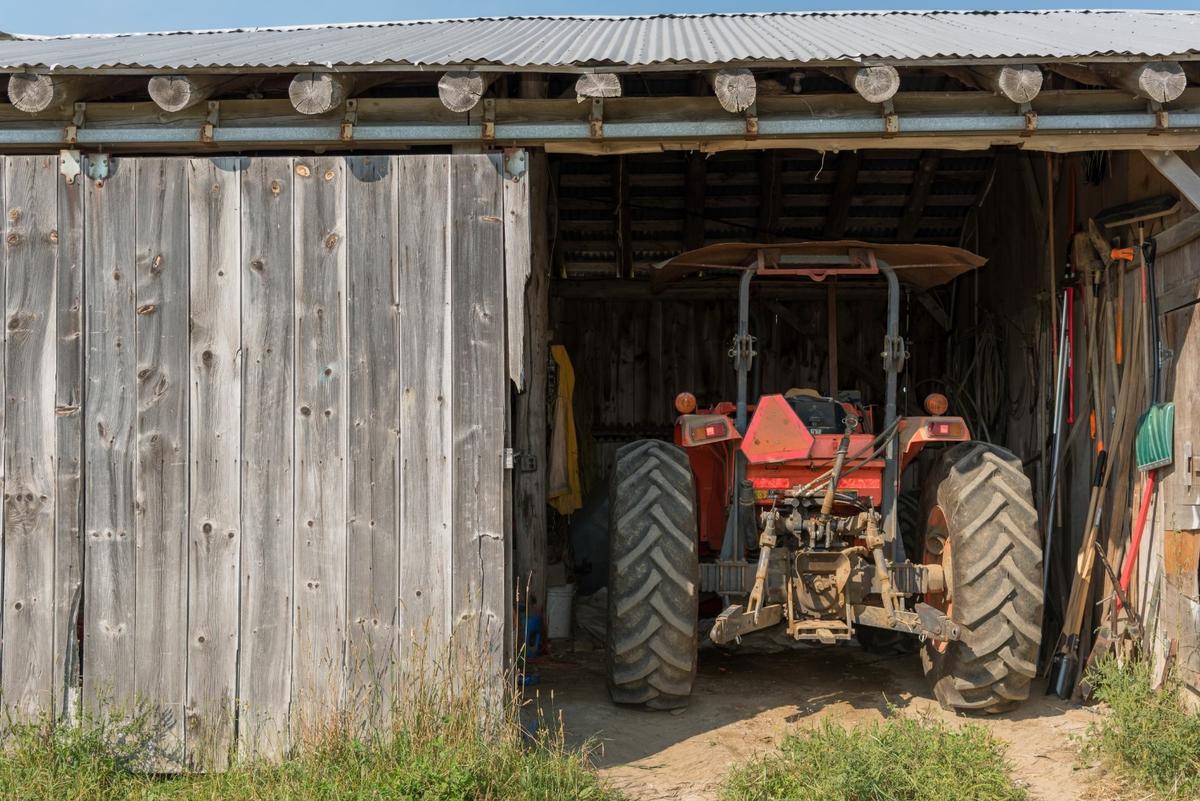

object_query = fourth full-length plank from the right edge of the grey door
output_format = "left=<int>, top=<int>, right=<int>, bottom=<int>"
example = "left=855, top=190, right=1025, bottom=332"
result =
left=292, top=157, right=347, bottom=740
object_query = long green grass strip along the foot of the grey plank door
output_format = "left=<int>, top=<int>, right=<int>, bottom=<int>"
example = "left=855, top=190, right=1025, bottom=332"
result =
left=0, top=681, right=620, bottom=801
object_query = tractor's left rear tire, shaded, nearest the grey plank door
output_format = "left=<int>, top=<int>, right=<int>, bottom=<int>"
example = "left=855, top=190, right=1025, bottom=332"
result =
left=608, top=440, right=700, bottom=709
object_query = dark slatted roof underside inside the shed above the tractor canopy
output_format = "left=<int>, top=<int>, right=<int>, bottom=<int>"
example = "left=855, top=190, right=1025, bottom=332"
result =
left=552, top=150, right=992, bottom=277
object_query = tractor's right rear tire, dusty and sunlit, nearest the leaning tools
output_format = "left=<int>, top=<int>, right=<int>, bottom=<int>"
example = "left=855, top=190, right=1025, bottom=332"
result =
left=922, top=442, right=1042, bottom=712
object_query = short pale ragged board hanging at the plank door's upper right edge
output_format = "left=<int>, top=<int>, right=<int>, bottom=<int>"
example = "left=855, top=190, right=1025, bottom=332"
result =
left=504, top=152, right=533, bottom=392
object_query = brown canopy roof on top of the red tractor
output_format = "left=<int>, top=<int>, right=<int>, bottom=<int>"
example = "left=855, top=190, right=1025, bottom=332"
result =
left=650, top=240, right=988, bottom=291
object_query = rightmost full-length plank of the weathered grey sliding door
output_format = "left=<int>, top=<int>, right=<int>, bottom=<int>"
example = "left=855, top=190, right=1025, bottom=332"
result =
left=450, top=156, right=510, bottom=688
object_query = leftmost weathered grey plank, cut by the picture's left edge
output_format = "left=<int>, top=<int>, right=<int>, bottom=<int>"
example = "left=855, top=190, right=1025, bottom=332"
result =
left=0, top=156, right=58, bottom=721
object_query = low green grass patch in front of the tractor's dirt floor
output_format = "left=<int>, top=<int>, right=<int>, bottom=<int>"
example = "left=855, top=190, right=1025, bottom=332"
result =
left=721, top=717, right=1026, bottom=801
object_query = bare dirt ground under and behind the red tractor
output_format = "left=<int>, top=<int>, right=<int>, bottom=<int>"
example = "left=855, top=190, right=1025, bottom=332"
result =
left=536, top=644, right=1096, bottom=801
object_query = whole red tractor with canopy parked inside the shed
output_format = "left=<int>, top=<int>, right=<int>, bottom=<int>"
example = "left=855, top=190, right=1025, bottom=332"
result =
left=608, top=242, right=1043, bottom=712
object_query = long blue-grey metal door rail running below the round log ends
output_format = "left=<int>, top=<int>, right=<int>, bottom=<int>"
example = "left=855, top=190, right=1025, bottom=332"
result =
left=0, top=110, right=1200, bottom=147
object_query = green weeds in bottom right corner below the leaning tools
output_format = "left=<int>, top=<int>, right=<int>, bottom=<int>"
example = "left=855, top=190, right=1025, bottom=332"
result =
left=1082, top=660, right=1200, bottom=801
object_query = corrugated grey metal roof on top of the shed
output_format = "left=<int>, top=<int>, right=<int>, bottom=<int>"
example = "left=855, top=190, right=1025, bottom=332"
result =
left=0, top=11, right=1200, bottom=70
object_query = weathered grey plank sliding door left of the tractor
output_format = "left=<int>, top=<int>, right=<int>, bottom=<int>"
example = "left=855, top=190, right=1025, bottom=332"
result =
left=0, top=156, right=528, bottom=770
